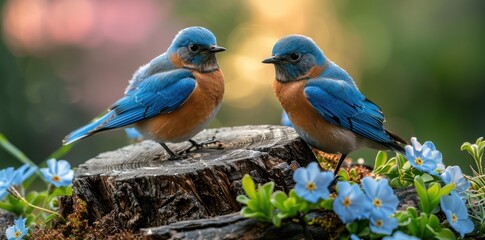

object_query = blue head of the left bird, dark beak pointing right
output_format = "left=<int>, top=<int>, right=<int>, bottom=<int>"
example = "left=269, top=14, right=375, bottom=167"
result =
left=167, top=27, right=226, bottom=72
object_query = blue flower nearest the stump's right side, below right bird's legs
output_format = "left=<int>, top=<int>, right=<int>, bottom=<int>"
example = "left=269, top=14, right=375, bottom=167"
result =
left=293, top=162, right=334, bottom=203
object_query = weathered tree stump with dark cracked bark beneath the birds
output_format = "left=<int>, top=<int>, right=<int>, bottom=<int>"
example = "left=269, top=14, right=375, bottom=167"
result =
left=73, top=126, right=315, bottom=231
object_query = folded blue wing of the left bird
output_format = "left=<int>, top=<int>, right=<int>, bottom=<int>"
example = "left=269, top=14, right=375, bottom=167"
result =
left=103, top=70, right=196, bottom=128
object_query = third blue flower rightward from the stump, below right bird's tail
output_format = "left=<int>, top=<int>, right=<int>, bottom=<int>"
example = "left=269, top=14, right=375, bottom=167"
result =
left=362, top=177, right=399, bottom=217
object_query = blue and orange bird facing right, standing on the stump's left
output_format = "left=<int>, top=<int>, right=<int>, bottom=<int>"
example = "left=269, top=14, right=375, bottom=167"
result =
left=63, top=27, right=225, bottom=158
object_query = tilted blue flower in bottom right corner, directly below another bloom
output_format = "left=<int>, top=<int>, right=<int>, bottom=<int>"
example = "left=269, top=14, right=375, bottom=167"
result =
left=440, top=192, right=474, bottom=237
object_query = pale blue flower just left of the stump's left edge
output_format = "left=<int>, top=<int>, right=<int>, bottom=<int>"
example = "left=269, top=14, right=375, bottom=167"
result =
left=40, top=158, right=74, bottom=187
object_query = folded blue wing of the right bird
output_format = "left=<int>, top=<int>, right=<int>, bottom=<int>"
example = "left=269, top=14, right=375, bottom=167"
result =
left=304, top=78, right=392, bottom=143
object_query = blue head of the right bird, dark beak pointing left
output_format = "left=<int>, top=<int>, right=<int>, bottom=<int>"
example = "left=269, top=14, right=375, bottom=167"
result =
left=263, top=35, right=327, bottom=82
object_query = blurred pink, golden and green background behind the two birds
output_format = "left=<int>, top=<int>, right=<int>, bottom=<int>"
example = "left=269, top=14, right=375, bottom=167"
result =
left=0, top=0, right=485, bottom=172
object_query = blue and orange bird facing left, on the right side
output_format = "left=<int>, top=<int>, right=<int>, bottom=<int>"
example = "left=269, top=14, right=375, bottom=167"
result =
left=263, top=35, right=406, bottom=174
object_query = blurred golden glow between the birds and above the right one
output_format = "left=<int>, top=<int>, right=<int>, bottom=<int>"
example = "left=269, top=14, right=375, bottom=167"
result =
left=221, top=0, right=359, bottom=109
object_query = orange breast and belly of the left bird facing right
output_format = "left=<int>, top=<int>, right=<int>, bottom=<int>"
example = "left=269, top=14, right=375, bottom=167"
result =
left=137, top=70, right=224, bottom=142
